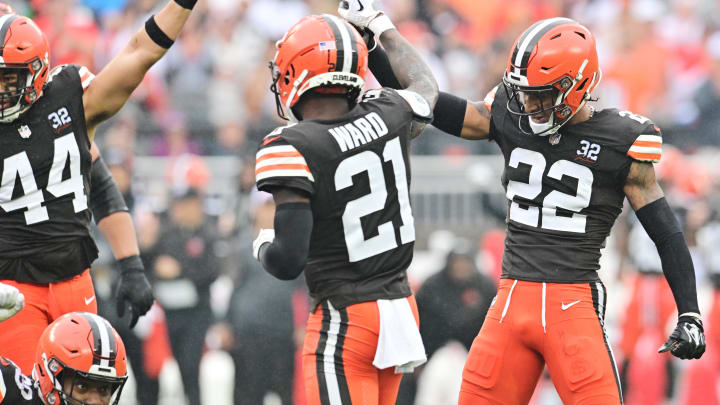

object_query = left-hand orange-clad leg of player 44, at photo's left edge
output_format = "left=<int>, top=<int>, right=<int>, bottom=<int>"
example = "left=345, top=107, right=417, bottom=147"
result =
left=0, top=280, right=50, bottom=375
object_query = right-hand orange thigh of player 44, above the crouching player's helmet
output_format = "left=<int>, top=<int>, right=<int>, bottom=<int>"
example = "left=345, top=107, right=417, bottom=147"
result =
left=48, top=269, right=97, bottom=320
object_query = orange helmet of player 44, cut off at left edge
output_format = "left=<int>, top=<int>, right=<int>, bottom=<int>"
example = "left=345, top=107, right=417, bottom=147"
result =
left=0, top=15, right=50, bottom=123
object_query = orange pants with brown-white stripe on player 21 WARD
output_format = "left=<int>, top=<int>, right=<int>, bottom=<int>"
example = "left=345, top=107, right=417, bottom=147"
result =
left=303, top=296, right=419, bottom=405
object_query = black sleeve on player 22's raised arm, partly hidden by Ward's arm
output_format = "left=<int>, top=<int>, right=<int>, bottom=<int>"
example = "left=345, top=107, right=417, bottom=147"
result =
left=368, top=46, right=467, bottom=136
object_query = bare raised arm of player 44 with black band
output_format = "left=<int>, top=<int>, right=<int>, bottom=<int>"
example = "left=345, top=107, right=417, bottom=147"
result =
left=83, top=0, right=197, bottom=136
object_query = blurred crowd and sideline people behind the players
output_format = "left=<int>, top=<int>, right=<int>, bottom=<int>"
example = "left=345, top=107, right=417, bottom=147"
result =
left=8, top=0, right=720, bottom=405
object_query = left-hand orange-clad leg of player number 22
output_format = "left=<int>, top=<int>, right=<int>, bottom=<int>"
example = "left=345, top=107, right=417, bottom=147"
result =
left=458, top=279, right=544, bottom=405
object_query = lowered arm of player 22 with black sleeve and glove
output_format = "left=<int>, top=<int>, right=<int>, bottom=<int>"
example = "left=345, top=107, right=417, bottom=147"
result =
left=624, top=161, right=705, bottom=359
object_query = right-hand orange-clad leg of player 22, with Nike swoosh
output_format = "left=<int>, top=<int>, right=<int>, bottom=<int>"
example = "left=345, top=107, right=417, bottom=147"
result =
left=543, top=282, right=622, bottom=405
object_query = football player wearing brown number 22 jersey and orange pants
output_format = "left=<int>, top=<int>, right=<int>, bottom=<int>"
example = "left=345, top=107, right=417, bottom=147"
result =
left=358, top=9, right=705, bottom=405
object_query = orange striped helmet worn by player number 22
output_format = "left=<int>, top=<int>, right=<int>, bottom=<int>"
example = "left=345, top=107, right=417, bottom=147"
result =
left=503, top=17, right=601, bottom=135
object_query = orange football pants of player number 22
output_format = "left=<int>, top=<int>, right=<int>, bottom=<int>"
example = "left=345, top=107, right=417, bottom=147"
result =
left=458, top=279, right=622, bottom=405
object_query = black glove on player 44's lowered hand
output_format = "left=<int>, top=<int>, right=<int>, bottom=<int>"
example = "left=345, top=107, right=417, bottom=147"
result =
left=115, top=256, right=155, bottom=328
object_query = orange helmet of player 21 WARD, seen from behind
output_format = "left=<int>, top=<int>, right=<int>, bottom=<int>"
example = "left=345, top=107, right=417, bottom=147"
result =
left=270, top=14, right=368, bottom=121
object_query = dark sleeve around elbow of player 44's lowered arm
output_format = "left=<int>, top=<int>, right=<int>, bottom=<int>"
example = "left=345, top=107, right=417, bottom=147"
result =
left=88, top=156, right=128, bottom=223
